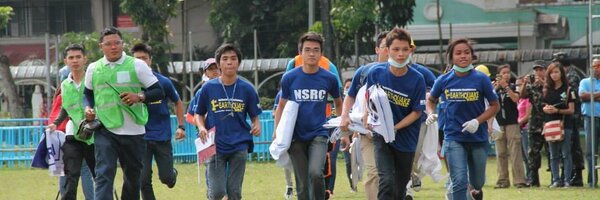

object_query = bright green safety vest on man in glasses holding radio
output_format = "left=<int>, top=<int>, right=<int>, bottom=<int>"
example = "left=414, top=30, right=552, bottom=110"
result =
left=92, top=55, right=148, bottom=129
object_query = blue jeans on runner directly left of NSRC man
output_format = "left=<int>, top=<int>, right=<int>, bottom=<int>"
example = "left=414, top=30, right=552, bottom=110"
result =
left=206, top=150, right=248, bottom=200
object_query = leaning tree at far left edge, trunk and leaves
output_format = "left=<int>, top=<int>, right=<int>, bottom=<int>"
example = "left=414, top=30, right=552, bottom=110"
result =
left=0, top=7, right=24, bottom=118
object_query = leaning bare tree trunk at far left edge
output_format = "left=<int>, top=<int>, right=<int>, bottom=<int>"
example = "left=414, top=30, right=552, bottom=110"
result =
left=0, top=55, right=23, bottom=118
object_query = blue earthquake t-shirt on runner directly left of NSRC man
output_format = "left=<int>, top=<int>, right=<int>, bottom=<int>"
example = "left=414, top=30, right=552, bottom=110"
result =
left=195, top=78, right=262, bottom=154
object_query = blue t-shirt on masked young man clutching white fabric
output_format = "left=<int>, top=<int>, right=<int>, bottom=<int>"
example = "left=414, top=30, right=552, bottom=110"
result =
left=367, top=63, right=425, bottom=152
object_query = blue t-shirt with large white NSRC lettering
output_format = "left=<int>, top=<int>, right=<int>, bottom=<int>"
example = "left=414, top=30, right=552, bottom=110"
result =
left=281, top=67, right=340, bottom=142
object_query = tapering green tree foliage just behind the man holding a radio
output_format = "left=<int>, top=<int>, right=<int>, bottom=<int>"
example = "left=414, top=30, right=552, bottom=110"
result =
left=121, top=0, right=181, bottom=76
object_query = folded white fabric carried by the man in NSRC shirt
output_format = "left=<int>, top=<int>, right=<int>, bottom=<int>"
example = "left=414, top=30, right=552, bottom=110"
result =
left=269, top=101, right=298, bottom=167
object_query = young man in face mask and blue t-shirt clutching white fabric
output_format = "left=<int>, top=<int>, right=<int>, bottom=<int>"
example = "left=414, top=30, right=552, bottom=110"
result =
left=367, top=28, right=426, bottom=200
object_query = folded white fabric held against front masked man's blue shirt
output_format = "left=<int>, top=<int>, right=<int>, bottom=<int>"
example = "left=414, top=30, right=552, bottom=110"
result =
left=367, top=85, right=396, bottom=143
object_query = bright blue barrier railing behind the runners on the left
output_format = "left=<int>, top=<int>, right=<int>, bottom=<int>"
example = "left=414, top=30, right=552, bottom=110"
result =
left=0, top=110, right=274, bottom=169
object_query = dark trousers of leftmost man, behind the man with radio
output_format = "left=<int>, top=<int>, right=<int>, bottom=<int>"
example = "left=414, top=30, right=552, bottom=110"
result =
left=62, top=135, right=96, bottom=199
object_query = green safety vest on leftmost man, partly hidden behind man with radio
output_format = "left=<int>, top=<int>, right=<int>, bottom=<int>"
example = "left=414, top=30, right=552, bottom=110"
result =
left=61, top=78, right=94, bottom=145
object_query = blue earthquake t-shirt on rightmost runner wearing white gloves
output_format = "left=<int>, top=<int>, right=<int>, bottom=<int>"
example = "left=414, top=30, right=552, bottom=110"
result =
left=430, top=70, right=498, bottom=142
